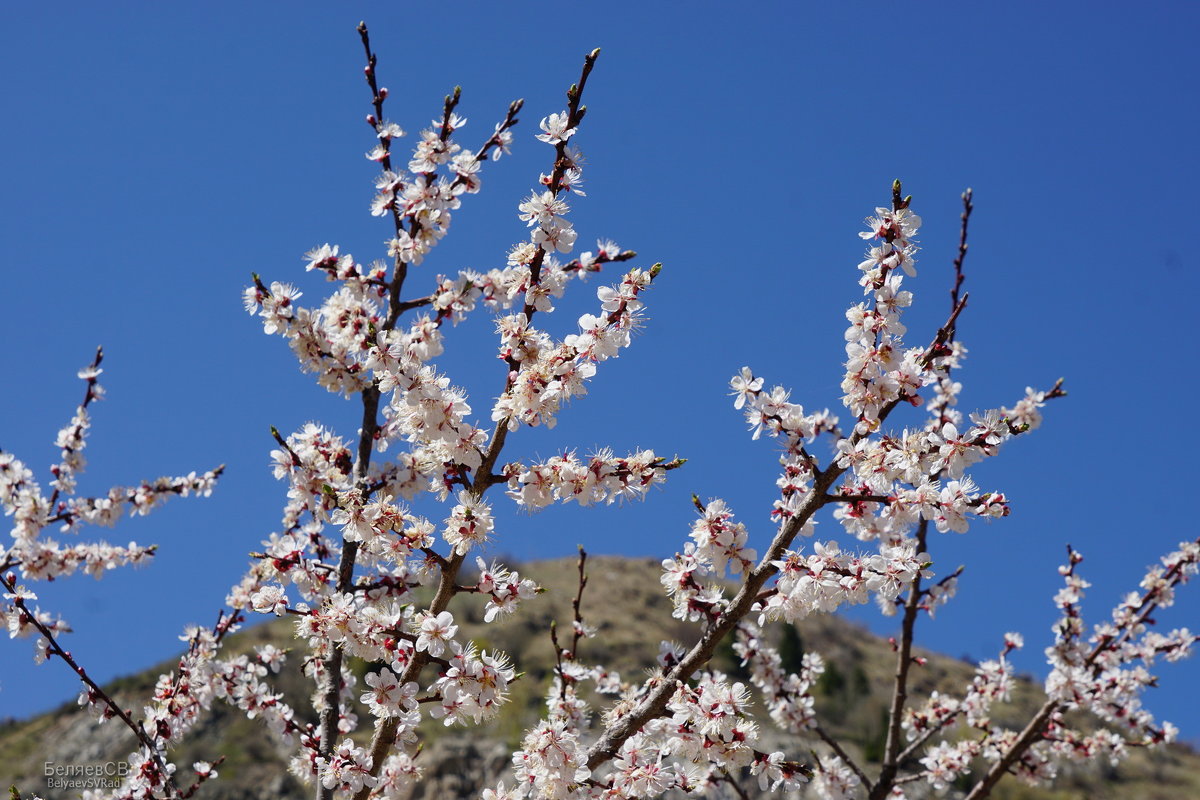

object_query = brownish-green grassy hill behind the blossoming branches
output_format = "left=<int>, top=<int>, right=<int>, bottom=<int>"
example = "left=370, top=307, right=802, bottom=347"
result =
left=0, top=558, right=1200, bottom=800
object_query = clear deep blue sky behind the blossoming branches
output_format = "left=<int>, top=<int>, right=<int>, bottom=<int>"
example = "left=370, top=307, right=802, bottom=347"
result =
left=0, top=2, right=1200, bottom=741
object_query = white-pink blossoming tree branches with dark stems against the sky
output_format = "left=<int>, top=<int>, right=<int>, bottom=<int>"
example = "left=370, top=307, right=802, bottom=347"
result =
left=0, top=25, right=1200, bottom=800
